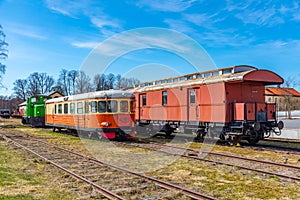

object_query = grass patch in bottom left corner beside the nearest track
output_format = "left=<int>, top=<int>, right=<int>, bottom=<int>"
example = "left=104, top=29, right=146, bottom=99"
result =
left=0, top=141, right=78, bottom=200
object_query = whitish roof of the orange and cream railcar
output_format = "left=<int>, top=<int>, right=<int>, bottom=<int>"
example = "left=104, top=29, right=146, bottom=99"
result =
left=46, top=90, right=134, bottom=103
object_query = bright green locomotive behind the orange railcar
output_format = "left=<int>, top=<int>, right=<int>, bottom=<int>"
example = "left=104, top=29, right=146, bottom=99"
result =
left=22, top=94, right=52, bottom=127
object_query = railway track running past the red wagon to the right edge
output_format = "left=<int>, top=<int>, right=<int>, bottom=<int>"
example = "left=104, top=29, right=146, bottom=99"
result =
left=116, top=142, right=300, bottom=181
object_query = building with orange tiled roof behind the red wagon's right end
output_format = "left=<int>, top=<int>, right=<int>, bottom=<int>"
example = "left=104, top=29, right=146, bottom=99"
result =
left=265, top=87, right=300, bottom=111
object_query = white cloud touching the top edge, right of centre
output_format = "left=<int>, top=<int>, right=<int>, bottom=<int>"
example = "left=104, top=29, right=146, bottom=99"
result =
left=136, top=0, right=196, bottom=12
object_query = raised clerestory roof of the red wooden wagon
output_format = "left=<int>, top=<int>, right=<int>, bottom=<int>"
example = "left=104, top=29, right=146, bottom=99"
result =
left=133, top=65, right=284, bottom=92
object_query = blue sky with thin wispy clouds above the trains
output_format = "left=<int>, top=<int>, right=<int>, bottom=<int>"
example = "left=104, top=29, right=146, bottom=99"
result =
left=0, top=0, right=300, bottom=95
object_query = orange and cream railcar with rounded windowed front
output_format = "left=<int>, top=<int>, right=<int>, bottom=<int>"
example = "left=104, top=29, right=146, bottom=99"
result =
left=45, top=90, right=135, bottom=139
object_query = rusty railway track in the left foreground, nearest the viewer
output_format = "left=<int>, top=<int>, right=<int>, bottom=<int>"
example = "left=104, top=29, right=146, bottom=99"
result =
left=0, top=134, right=216, bottom=199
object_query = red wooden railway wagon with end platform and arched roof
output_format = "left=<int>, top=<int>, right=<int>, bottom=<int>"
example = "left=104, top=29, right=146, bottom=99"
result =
left=134, top=65, right=283, bottom=144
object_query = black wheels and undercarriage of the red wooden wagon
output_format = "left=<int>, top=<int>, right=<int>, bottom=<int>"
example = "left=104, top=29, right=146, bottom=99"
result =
left=137, top=121, right=284, bottom=145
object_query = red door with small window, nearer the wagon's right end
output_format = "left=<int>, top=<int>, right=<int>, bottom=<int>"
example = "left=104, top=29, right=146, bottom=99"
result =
left=187, top=88, right=199, bottom=122
